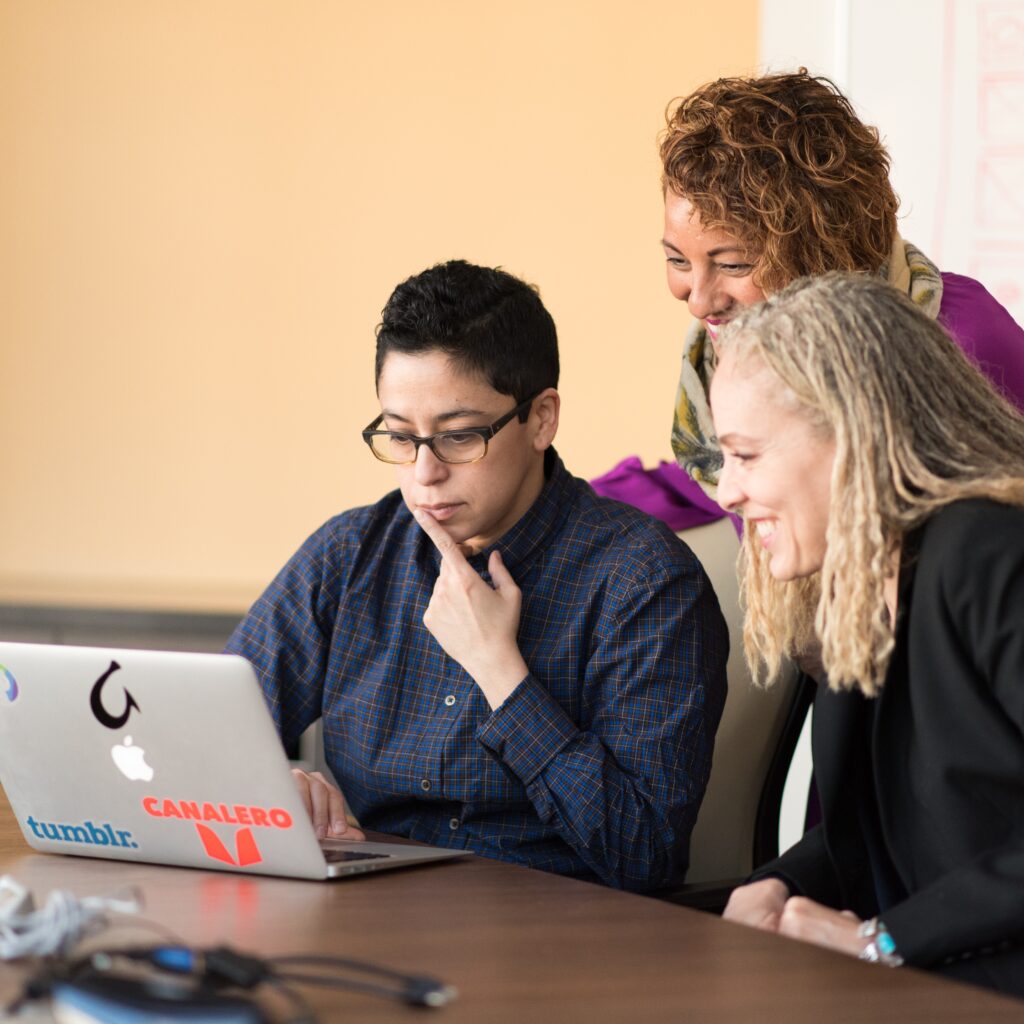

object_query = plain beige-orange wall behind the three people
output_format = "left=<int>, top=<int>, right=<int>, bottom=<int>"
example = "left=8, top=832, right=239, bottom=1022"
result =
left=0, top=0, right=758, bottom=609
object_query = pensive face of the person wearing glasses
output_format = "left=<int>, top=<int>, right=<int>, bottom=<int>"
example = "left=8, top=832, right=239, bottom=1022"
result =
left=377, top=350, right=558, bottom=551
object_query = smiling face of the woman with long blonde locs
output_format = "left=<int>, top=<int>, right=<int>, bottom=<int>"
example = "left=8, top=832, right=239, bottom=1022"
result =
left=711, top=352, right=836, bottom=580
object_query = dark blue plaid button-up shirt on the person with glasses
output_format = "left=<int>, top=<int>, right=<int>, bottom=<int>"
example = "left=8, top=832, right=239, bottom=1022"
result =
left=227, top=453, right=728, bottom=891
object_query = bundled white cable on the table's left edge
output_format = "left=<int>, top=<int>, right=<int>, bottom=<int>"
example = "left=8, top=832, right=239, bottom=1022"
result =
left=0, top=876, right=141, bottom=959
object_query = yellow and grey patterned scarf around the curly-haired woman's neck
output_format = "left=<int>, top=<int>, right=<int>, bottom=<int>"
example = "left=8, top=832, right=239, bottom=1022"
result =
left=672, top=234, right=942, bottom=498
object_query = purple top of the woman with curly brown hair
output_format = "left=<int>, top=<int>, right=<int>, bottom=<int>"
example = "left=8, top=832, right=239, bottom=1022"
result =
left=590, top=273, right=1024, bottom=530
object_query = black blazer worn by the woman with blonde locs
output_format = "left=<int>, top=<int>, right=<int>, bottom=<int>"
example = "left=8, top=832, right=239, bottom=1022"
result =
left=754, top=501, right=1024, bottom=995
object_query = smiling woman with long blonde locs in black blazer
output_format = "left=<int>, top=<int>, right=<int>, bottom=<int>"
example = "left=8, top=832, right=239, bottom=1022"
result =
left=711, top=273, right=1024, bottom=996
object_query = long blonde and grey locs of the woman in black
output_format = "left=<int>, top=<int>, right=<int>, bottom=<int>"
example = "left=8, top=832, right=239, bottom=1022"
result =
left=719, top=273, right=1024, bottom=696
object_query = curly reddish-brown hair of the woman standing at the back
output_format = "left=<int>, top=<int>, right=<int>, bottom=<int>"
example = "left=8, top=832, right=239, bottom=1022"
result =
left=660, top=68, right=899, bottom=293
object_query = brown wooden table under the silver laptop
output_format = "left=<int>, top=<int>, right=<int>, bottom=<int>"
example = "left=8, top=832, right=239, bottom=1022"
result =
left=0, top=791, right=1024, bottom=1024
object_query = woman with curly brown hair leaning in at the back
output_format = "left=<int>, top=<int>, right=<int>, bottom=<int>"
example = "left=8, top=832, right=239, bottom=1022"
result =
left=662, top=69, right=1024, bottom=496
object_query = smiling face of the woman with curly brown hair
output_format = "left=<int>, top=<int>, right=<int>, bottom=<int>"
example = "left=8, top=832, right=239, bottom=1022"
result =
left=662, top=190, right=765, bottom=342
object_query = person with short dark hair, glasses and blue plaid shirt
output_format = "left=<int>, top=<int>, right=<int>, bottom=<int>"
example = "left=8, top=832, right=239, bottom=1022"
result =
left=227, top=261, right=728, bottom=891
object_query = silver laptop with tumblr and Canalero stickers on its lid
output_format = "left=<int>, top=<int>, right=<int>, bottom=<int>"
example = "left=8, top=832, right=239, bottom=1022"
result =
left=0, top=642, right=468, bottom=879
